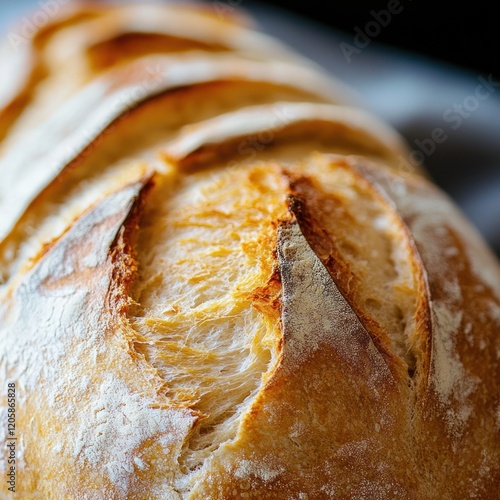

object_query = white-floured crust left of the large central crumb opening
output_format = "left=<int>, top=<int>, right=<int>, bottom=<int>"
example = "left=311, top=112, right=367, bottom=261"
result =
left=0, top=181, right=199, bottom=498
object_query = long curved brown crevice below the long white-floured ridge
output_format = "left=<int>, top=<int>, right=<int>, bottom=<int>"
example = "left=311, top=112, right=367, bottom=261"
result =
left=0, top=80, right=324, bottom=285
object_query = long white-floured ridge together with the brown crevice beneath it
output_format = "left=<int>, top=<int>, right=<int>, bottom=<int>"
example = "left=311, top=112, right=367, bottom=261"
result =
left=0, top=55, right=356, bottom=290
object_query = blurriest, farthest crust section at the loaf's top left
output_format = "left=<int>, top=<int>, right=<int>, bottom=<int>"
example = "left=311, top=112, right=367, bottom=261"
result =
left=0, top=1, right=328, bottom=149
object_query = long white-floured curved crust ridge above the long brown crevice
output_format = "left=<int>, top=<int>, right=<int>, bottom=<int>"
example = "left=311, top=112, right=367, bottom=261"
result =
left=0, top=57, right=344, bottom=239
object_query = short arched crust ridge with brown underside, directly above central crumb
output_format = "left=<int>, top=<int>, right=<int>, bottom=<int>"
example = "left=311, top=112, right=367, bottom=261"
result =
left=163, top=102, right=407, bottom=170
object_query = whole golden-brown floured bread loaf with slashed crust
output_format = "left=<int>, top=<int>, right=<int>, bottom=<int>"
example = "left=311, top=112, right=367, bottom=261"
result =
left=0, top=4, right=500, bottom=499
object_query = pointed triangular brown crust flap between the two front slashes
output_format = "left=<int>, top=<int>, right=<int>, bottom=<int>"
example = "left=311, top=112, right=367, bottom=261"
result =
left=188, top=221, right=416, bottom=498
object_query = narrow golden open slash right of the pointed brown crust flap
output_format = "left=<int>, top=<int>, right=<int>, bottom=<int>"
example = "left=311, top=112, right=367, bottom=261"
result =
left=289, top=155, right=422, bottom=375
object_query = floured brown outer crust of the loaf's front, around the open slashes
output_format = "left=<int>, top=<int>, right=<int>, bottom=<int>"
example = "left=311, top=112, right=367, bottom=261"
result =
left=2, top=157, right=499, bottom=498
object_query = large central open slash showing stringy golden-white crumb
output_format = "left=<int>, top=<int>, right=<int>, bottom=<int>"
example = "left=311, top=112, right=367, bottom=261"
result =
left=129, top=165, right=287, bottom=472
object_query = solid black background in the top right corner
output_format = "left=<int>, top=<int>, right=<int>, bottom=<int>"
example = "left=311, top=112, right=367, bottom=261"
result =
left=254, top=0, right=500, bottom=77
